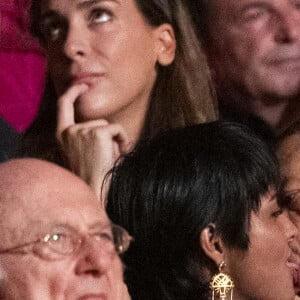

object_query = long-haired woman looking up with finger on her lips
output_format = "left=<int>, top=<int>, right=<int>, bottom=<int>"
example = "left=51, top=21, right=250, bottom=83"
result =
left=22, top=0, right=217, bottom=197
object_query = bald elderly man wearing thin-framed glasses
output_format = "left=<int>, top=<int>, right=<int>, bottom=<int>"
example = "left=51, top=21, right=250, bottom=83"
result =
left=0, top=159, right=130, bottom=300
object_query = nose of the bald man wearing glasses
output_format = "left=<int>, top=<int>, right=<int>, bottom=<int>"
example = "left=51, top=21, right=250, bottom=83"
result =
left=76, top=238, right=121, bottom=277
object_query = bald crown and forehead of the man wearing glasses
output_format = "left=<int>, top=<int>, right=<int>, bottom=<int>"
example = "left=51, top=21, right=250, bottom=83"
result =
left=0, top=159, right=107, bottom=248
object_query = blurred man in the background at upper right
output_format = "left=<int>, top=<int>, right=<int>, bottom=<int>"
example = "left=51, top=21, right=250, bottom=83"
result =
left=190, top=0, right=300, bottom=131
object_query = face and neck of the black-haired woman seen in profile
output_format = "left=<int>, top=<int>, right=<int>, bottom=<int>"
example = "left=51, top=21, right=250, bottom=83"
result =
left=225, top=193, right=297, bottom=300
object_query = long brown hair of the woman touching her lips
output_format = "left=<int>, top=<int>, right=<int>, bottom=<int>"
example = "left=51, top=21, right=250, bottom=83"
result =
left=22, top=0, right=217, bottom=162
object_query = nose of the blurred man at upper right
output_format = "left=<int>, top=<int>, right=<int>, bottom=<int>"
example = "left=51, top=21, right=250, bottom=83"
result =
left=274, top=8, right=300, bottom=43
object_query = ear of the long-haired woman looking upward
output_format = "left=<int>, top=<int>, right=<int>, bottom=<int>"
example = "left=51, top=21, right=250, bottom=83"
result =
left=156, top=23, right=176, bottom=66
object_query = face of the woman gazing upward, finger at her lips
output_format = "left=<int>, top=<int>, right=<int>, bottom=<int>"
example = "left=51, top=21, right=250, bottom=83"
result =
left=41, top=0, right=169, bottom=121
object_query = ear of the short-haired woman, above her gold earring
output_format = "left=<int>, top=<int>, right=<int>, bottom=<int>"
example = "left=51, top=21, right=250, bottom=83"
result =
left=200, top=224, right=224, bottom=266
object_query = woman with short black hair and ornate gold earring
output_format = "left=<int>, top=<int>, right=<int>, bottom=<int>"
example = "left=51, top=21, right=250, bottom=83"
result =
left=107, top=121, right=299, bottom=300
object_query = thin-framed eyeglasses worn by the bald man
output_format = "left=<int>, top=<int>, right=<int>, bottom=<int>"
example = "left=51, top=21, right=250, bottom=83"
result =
left=0, top=224, right=132, bottom=260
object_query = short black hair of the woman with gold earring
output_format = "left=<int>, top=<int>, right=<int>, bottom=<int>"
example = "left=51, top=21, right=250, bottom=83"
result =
left=107, top=121, right=280, bottom=300
